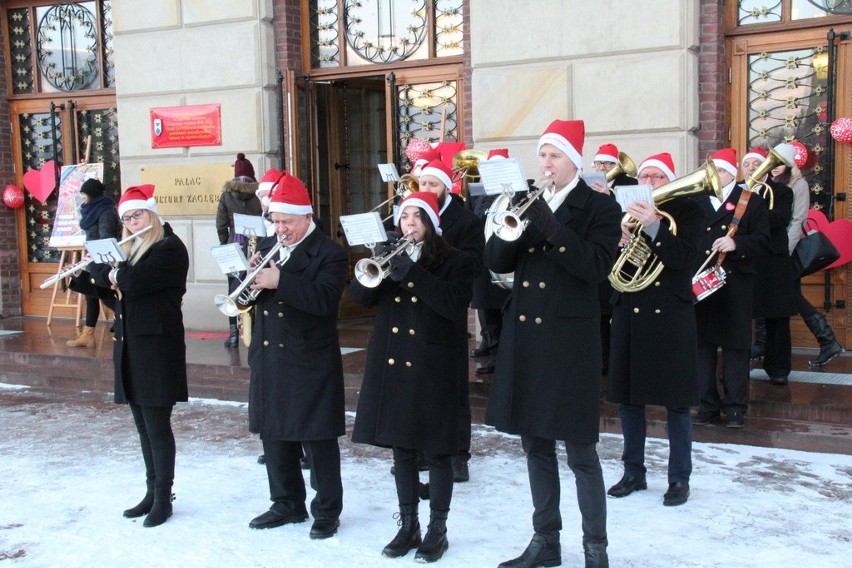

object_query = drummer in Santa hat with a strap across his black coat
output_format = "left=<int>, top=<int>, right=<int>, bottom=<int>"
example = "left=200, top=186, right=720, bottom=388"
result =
left=692, top=148, right=769, bottom=428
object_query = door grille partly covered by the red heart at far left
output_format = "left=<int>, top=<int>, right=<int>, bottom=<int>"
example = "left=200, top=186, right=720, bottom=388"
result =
left=18, top=112, right=62, bottom=262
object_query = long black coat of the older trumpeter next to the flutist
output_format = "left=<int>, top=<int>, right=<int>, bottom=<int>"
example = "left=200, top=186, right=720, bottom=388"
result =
left=248, top=229, right=348, bottom=441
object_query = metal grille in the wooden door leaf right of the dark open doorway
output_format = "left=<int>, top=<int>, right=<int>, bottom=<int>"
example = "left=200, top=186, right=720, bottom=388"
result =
left=397, top=81, right=458, bottom=172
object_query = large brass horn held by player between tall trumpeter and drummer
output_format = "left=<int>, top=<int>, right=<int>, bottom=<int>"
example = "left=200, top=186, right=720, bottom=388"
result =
left=609, top=158, right=722, bottom=292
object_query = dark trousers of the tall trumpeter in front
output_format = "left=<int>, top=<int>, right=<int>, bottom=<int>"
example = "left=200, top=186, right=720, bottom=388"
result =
left=521, top=436, right=607, bottom=543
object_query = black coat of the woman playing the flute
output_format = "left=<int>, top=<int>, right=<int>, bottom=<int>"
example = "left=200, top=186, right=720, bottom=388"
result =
left=71, top=223, right=189, bottom=406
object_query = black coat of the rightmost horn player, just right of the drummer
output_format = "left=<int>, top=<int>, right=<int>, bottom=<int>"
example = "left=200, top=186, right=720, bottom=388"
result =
left=754, top=180, right=798, bottom=318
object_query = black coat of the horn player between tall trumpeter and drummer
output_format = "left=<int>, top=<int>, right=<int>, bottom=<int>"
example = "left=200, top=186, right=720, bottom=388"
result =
left=607, top=198, right=704, bottom=408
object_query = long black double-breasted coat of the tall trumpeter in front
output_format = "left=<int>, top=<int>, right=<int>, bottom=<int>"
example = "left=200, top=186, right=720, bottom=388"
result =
left=485, top=179, right=621, bottom=443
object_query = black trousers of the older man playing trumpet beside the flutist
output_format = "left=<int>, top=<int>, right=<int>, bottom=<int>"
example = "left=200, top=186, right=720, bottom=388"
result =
left=262, top=438, right=343, bottom=519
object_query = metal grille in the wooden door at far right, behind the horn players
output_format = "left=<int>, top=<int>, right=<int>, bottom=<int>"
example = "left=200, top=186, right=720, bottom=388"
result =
left=748, top=46, right=831, bottom=209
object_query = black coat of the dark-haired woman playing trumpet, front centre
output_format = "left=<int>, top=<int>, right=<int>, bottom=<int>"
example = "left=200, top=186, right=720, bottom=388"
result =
left=349, top=249, right=478, bottom=455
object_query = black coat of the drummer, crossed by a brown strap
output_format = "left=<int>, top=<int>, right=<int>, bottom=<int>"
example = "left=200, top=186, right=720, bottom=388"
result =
left=693, top=185, right=769, bottom=349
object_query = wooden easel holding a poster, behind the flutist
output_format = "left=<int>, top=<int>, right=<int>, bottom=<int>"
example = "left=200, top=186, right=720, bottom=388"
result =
left=47, top=137, right=109, bottom=327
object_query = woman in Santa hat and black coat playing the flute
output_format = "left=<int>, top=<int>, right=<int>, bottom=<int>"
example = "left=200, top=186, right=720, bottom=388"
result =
left=71, top=185, right=189, bottom=527
